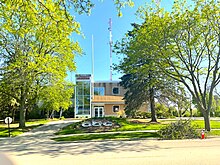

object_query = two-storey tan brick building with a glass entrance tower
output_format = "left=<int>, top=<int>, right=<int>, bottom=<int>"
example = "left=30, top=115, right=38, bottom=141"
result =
left=75, top=74, right=125, bottom=118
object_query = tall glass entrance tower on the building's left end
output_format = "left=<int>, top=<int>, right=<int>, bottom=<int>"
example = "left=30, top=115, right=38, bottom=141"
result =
left=75, top=74, right=92, bottom=118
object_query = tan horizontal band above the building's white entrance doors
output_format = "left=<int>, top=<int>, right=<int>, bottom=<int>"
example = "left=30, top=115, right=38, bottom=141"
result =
left=92, top=95, right=125, bottom=104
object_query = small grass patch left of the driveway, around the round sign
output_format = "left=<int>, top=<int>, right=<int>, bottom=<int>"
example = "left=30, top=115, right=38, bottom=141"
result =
left=0, top=119, right=50, bottom=138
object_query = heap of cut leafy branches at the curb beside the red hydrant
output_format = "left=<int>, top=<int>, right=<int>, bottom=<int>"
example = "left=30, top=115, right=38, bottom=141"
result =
left=158, top=120, right=199, bottom=140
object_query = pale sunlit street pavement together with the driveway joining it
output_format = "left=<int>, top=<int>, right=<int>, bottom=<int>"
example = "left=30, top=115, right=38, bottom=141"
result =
left=0, top=121, right=220, bottom=165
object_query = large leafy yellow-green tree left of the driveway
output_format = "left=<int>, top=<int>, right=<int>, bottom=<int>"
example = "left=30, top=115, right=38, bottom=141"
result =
left=0, top=1, right=81, bottom=127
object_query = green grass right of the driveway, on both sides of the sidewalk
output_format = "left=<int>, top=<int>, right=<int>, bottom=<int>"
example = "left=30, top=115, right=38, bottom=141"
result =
left=53, top=117, right=220, bottom=141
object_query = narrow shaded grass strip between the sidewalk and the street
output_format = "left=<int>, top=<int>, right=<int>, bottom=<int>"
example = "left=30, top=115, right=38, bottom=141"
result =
left=53, top=132, right=159, bottom=141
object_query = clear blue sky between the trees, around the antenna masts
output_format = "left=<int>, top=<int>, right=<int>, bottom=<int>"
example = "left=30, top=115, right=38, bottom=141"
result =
left=68, top=0, right=173, bottom=82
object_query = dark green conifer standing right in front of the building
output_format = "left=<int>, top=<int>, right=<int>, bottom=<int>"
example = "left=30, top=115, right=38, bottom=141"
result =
left=115, top=24, right=182, bottom=122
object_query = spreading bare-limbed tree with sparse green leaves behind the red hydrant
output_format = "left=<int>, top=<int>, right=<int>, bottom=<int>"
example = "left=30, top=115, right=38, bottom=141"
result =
left=126, top=0, right=220, bottom=131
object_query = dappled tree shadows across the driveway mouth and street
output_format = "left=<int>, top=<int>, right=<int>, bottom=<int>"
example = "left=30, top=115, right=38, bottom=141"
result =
left=0, top=124, right=160, bottom=157
